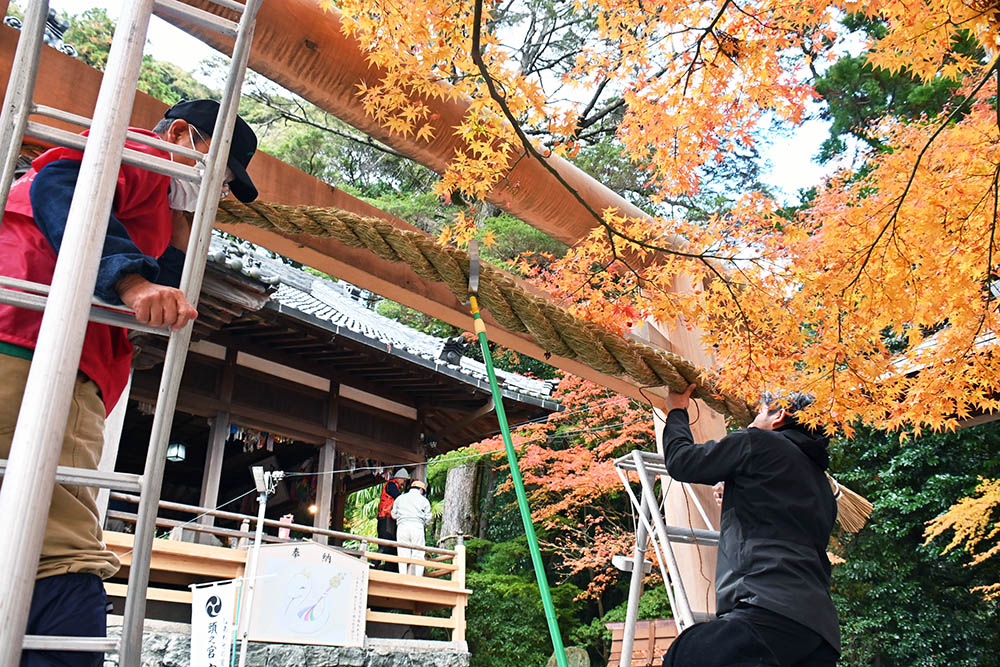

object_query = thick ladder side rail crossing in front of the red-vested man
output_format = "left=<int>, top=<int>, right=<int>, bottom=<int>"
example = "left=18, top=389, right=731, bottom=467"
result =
left=0, top=0, right=152, bottom=665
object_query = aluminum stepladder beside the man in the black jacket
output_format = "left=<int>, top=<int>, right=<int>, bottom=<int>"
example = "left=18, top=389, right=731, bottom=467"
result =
left=615, top=449, right=719, bottom=667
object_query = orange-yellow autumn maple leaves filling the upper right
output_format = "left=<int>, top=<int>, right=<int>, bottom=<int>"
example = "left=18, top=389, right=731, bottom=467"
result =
left=322, top=0, right=1000, bottom=596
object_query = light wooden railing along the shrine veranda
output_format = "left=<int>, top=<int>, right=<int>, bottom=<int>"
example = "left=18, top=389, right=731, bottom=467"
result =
left=104, top=493, right=471, bottom=642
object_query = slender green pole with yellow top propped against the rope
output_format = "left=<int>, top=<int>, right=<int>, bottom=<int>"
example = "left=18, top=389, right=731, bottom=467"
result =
left=469, top=295, right=568, bottom=667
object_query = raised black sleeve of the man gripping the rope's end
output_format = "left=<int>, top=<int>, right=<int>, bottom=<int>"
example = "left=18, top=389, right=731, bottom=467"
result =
left=663, top=409, right=750, bottom=484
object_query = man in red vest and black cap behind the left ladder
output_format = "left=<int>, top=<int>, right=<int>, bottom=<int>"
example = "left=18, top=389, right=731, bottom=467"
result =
left=0, top=100, right=257, bottom=665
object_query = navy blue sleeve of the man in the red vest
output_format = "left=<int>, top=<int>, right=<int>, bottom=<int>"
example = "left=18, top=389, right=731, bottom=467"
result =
left=30, top=160, right=159, bottom=304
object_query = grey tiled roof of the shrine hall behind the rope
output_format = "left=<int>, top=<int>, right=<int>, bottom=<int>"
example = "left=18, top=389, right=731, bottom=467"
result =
left=208, top=232, right=558, bottom=409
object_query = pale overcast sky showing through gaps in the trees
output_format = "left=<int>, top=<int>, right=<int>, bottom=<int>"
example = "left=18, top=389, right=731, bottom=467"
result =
left=39, top=0, right=828, bottom=203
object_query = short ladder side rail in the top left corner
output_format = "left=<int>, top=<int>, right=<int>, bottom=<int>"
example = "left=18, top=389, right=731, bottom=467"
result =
left=0, top=0, right=49, bottom=206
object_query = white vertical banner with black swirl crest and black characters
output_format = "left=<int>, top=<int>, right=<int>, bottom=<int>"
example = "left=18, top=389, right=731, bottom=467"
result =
left=191, top=581, right=239, bottom=667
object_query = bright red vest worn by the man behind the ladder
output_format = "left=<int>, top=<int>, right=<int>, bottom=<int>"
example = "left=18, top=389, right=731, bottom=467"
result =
left=0, top=128, right=172, bottom=412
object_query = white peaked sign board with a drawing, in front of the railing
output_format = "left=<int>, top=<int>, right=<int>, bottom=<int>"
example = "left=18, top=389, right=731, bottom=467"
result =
left=241, top=542, right=368, bottom=646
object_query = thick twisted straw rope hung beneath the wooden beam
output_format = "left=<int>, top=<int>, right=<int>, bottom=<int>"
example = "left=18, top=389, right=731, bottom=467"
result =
left=216, top=199, right=752, bottom=425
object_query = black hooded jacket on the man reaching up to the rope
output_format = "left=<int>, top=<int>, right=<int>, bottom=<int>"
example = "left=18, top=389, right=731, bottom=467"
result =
left=663, top=410, right=840, bottom=651
